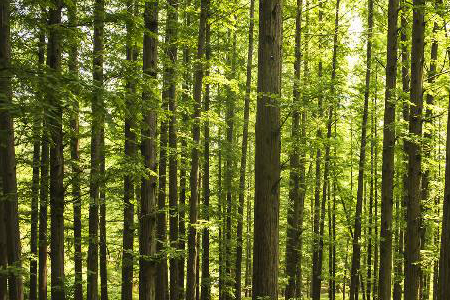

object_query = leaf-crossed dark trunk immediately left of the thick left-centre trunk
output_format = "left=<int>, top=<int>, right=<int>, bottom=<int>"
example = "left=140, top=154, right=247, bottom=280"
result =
left=121, top=0, right=138, bottom=300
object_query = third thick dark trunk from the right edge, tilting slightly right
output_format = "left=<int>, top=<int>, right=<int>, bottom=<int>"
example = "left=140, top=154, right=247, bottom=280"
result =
left=378, top=0, right=398, bottom=300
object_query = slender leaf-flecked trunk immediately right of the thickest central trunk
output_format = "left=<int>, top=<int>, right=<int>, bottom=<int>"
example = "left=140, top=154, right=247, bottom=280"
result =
left=284, top=0, right=302, bottom=300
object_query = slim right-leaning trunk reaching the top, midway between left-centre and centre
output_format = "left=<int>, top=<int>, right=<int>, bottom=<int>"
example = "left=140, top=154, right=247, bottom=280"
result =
left=186, top=0, right=209, bottom=300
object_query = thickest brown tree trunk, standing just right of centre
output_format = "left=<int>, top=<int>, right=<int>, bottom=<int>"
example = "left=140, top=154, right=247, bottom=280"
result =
left=252, top=0, right=282, bottom=300
